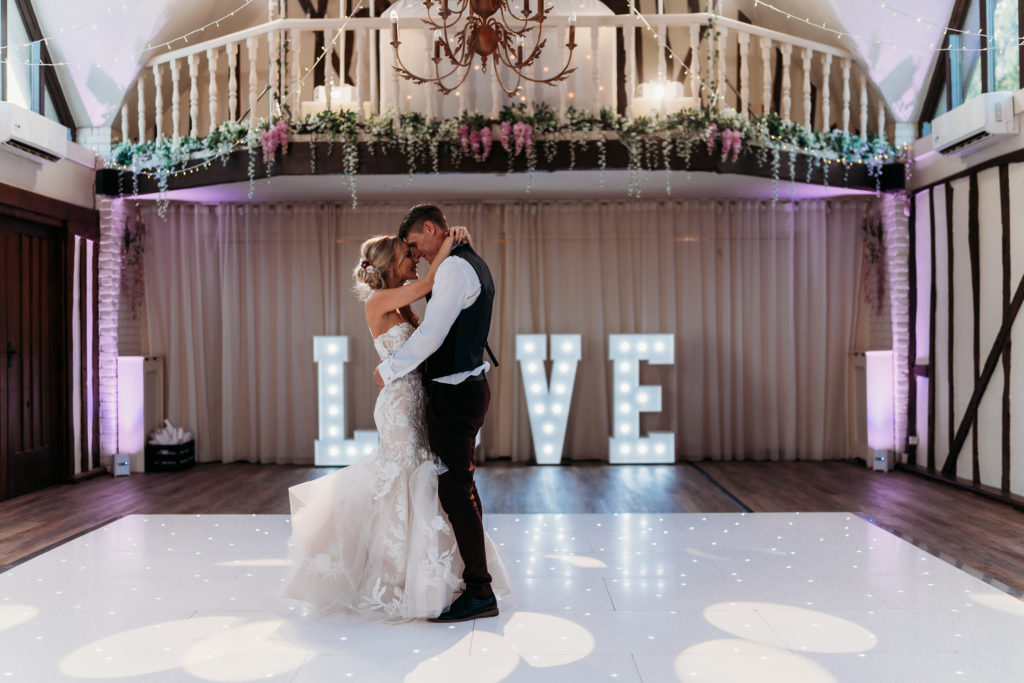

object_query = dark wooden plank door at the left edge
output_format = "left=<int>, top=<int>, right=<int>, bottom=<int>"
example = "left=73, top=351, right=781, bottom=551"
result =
left=0, top=214, right=67, bottom=499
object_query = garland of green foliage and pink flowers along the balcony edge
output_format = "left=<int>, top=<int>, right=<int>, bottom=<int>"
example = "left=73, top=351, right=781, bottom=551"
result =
left=109, top=103, right=907, bottom=209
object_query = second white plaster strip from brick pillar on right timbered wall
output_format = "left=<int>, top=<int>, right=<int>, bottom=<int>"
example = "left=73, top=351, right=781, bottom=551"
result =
left=932, top=185, right=950, bottom=469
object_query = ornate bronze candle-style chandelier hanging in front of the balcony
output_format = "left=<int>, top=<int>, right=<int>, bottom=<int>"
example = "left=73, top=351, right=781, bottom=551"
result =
left=391, top=0, right=577, bottom=97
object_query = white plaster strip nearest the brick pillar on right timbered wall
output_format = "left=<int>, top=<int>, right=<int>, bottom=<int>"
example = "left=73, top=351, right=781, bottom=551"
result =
left=908, top=189, right=934, bottom=465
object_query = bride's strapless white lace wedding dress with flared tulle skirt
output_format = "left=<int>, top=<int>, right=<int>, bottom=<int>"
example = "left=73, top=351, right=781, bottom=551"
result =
left=285, top=323, right=509, bottom=621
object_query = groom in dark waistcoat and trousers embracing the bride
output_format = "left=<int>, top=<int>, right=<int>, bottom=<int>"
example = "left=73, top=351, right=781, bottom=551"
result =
left=374, top=204, right=498, bottom=623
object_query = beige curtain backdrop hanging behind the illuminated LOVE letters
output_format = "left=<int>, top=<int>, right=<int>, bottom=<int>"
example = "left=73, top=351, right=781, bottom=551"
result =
left=144, top=200, right=866, bottom=463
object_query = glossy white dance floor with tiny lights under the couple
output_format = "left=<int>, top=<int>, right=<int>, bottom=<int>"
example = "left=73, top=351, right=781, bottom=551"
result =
left=0, top=513, right=1024, bottom=683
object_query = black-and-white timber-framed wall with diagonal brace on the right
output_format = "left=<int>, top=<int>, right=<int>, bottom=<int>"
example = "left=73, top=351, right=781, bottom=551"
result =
left=907, top=151, right=1024, bottom=507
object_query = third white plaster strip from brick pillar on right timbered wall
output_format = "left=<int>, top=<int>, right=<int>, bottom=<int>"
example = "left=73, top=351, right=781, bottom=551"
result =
left=936, top=178, right=975, bottom=479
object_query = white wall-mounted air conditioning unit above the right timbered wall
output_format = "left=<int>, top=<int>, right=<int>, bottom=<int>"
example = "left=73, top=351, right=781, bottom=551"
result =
left=932, top=92, right=1018, bottom=155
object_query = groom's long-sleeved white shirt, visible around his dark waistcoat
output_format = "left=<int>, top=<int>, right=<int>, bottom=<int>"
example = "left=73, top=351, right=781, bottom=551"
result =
left=377, top=256, right=490, bottom=384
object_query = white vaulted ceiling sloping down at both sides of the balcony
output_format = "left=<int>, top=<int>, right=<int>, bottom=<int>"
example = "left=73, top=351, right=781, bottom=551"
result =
left=32, top=0, right=953, bottom=127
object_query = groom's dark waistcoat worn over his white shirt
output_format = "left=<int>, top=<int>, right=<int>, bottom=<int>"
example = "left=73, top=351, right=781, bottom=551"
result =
left=423, top=245, right=495, bottom=380
